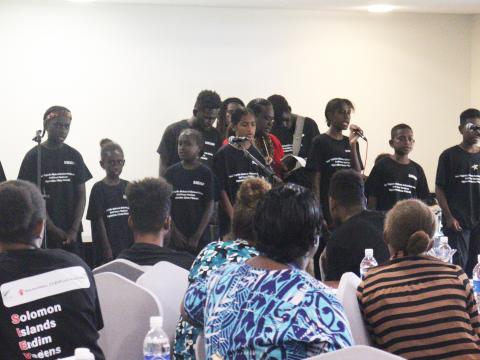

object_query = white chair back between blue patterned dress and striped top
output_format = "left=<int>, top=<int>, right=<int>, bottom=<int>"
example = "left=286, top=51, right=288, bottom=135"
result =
left=337, top=272, right=372, bottom=345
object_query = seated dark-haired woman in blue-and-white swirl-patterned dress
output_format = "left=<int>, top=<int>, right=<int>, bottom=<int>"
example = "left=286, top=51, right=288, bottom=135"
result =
left=184, top=184, right=352, bottom=359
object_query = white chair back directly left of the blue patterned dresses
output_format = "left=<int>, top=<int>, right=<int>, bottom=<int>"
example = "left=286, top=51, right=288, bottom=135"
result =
left=137, top=261, right=188, bottom=343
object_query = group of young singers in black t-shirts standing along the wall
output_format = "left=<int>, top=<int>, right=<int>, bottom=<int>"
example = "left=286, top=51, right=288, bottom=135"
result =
left=0, top=90, right=480, bottom=272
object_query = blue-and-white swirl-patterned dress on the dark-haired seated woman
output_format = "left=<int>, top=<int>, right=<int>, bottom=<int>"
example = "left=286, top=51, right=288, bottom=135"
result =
left=184, top=263, right=353, bottom=360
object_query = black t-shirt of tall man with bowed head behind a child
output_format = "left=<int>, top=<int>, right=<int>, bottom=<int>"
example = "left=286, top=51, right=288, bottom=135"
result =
left=157, top=120, right=222, bottom=168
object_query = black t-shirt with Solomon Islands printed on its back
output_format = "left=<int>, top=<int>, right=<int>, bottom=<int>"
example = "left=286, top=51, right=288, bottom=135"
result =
left=0, top=249, right=105, bottom=360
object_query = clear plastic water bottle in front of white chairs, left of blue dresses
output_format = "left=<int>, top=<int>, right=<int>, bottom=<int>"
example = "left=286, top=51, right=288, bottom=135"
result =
left=143, top=316, right=170, bottom=360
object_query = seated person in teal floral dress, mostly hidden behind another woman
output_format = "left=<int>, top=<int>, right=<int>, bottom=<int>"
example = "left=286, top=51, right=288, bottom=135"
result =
left=174, top=178, right=271, bottom=360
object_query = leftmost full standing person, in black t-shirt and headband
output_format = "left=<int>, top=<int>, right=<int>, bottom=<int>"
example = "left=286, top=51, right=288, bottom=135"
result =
left=18, top=106, right=92, bottom=256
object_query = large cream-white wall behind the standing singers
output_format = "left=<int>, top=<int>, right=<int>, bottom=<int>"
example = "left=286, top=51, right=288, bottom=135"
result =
left=0, top=3, right=472, bottom=202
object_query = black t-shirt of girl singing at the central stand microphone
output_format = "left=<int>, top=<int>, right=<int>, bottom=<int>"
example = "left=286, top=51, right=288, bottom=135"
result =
left=213, top=144, right=266, bottom=205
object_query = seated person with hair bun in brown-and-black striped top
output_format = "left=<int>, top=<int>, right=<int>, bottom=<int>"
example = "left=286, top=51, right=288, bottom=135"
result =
left=357, top=199, right=480, bottom=359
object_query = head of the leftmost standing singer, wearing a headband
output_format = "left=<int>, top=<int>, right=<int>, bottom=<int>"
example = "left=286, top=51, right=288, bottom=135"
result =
left=43, top=105, right=72, bottom=145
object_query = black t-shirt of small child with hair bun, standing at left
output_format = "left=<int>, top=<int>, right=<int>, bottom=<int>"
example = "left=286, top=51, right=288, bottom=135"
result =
left=87, top=179, right=133, bottom=260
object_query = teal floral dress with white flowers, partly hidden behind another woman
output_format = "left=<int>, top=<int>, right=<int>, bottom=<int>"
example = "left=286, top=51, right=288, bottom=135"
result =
left=173, top=239, right=258, bottom=360
